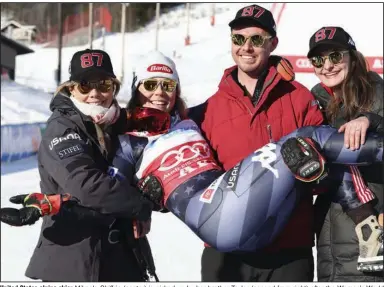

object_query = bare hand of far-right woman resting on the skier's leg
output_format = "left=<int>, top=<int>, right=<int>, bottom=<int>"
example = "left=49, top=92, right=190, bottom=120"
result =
left=339, top=117, right=370, bottom=150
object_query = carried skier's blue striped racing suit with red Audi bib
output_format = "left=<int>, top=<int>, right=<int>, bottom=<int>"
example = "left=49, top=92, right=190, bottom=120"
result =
left=110, top=116, right=383, bottom=252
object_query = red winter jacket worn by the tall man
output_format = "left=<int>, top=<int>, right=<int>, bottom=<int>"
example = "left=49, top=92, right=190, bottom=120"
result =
left=201, top=59, right=323, bottom=252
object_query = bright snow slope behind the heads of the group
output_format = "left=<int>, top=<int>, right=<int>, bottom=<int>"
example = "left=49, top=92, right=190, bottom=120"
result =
left=16, top=3, right=383, bottom=105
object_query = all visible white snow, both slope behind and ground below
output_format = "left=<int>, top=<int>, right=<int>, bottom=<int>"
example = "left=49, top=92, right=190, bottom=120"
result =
left=1, top=3, right=383, bottom=281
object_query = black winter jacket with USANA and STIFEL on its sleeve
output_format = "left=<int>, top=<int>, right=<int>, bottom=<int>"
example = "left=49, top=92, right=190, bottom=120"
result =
left=26, top=94, right=152, bottom=282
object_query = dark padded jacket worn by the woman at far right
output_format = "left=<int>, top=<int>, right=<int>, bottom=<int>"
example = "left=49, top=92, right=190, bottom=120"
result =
left=312, top=72, right=384, bottom=282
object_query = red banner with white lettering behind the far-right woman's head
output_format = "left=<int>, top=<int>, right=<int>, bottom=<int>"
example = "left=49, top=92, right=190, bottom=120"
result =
left=282, top=56, right=383, bottom=74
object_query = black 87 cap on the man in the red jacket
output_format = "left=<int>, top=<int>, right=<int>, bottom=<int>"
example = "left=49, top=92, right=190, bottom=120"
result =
left=228, top=4, right=277, bottom=37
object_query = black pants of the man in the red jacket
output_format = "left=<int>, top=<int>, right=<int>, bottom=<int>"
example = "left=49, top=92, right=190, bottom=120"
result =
left=201, top=247, right=314, bottom=282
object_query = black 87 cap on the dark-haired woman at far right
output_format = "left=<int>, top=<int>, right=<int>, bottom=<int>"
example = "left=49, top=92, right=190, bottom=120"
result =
left=308, top=27, right=356, bottom=58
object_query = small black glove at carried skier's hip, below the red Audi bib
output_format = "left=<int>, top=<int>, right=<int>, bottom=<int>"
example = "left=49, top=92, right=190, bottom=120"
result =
left=138, top=175, right=168, bottom=212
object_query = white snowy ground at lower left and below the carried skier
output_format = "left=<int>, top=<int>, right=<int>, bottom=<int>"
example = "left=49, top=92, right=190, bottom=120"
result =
left=1, top=157, right=203, bottom=281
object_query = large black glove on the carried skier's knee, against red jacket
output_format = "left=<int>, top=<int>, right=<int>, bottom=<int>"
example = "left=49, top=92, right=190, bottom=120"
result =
left=281, top=137, right=327, bottom=182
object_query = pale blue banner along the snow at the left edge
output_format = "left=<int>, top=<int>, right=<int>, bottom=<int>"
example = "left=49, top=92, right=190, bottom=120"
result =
left=1, top=123, right=46, bottom=162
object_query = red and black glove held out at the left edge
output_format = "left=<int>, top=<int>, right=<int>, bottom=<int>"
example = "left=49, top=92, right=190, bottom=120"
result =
left=0, top=193, right=71, bottom=226
